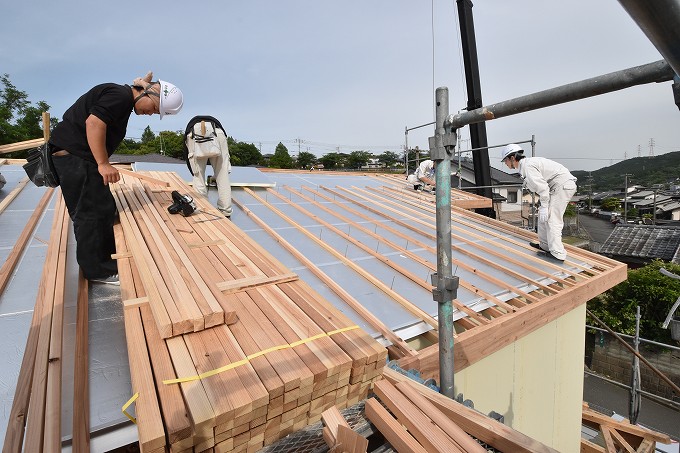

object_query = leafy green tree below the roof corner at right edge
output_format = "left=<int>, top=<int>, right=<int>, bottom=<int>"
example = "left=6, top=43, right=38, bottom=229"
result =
left=588, top=260, right=680, bottom=344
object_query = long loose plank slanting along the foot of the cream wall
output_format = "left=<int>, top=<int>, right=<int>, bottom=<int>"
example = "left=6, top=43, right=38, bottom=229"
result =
left=383, top=368, right=557, bottom=453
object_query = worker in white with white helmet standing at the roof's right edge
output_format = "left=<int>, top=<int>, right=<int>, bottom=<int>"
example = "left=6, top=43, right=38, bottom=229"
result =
left=501, top=143, right=576, bottom=261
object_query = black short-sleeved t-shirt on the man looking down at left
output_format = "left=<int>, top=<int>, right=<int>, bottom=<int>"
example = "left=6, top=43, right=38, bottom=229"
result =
left=50, top=83, right=134, bottom=162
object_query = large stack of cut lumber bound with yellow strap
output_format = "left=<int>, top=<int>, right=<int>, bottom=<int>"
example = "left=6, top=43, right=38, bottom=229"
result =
left=112, top=172, right=387, bottom=452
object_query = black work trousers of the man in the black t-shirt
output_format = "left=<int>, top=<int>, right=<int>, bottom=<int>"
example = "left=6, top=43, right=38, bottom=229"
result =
left=52, top=154, right=118, bottom=279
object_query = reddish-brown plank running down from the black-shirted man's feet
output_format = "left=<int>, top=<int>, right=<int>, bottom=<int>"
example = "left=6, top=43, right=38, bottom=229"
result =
left=71, top=271, right=90, bottom=453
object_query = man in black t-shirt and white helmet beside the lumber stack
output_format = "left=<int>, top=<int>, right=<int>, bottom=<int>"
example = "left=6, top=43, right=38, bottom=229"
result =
left=50, top=72, right=183, bottom=284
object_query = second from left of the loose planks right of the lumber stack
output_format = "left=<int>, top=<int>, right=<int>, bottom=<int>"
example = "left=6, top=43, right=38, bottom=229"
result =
left=373, top=380, right=463, bottom=452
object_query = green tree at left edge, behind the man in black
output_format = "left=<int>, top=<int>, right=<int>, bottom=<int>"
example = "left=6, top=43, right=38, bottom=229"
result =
left=0, top=74, right=53, bottom=157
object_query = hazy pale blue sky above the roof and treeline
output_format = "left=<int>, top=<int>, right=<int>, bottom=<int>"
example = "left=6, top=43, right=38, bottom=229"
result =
left=0, top=0, right=680, bottom=170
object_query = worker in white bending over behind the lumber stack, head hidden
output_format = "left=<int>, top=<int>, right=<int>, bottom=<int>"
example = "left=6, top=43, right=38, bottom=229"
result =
left=184, top=115, right=232, bottom=218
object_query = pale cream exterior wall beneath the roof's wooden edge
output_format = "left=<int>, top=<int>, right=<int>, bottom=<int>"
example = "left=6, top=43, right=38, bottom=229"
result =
left=454, top=304, right=586, bottom=452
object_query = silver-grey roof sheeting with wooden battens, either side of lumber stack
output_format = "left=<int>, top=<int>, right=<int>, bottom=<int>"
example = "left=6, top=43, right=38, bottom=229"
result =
left=0, top=164, right=625, bottom=446
